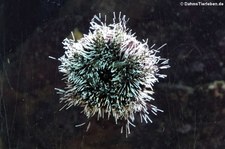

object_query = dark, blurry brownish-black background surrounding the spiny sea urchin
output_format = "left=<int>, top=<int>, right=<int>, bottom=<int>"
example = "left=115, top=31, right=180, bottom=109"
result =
left=0, top=0, right=225, bottom=149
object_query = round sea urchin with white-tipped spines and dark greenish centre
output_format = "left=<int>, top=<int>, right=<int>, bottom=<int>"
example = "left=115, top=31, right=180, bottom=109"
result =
left=57, top=13, right=169, bottom=135
